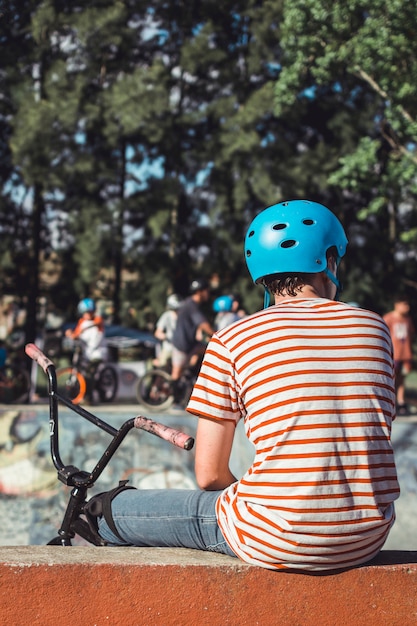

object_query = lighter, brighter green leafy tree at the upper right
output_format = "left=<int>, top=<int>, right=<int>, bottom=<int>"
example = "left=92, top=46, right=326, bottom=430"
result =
left=275, top=0, right=417, bottom=310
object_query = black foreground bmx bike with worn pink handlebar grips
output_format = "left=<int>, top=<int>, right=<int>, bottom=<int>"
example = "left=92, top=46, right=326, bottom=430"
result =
left=25, top=343, right=194, bottom=546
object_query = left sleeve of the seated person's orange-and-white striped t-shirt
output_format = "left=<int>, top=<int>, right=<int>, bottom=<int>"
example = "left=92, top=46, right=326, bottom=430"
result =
left=187, top=335, right=244, bottom=423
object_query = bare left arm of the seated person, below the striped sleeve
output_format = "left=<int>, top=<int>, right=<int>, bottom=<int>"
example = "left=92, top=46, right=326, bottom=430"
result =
left=195, top=417, right=237, bottom=491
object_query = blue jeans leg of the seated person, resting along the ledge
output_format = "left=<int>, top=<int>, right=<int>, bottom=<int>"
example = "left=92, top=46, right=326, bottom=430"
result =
left=98, top=489, right=236, bottom=556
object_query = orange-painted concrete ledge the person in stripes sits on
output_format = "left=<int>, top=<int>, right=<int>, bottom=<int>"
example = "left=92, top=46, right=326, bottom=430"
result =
left=0, top=546, right=417, bottom=626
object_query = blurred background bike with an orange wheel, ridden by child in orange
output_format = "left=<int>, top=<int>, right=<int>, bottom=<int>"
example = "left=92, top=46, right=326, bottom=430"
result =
left=56, top=342, right=118, bottom=404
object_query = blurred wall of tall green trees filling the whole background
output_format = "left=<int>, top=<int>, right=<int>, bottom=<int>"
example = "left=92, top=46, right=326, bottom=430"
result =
left=0, top=0, right=417, bottom=332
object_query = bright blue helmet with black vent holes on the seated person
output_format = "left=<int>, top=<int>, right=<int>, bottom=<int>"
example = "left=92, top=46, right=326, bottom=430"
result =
left=245, top=200, right=348, bottom=283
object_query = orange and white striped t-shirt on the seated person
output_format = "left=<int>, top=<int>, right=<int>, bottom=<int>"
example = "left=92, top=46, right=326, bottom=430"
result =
left=188, top=298, right=399, bottom=570
